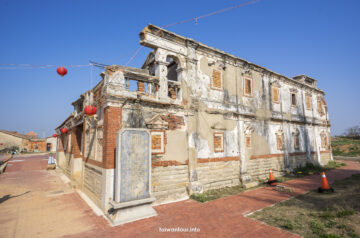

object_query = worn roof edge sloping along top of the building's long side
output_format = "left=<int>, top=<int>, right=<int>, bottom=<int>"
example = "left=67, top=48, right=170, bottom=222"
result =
left=139, top=24, right=325, bottom=95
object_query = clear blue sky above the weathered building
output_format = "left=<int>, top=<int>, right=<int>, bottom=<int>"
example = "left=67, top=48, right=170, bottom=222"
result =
left=0, top=0, right=360, bottom=136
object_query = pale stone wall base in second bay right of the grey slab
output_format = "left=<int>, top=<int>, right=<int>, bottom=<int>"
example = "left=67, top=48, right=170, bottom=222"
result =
left=196, top=159, right=240, bottom=191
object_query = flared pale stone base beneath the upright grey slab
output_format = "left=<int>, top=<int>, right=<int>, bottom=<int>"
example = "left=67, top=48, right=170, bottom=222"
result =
left=106, top=198, right=157, bottom=226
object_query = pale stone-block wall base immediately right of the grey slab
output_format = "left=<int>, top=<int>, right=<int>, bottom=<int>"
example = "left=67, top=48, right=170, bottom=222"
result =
left=151, top=165, right=189, bottom=204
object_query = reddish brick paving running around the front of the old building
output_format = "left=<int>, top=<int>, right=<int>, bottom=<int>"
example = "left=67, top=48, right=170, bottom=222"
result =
left=0, top=157, right=360, bottom=238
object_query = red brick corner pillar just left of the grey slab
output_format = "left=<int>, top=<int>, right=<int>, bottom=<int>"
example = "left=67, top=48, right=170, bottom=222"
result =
left=103, top=107, right=122, bottom=169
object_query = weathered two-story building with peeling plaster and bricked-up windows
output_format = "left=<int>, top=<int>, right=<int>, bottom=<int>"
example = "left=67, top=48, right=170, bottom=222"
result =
left=56, top=25, right=332, bottom=214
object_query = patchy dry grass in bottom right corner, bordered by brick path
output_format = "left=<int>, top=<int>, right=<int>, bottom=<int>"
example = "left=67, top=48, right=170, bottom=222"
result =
left=250, top=174, right=360, bottom=238
